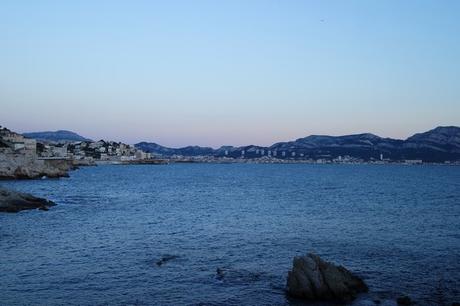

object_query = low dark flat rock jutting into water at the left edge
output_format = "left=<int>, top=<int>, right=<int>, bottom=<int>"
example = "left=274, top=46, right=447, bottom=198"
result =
left=0, top=187, right=56, bottom=212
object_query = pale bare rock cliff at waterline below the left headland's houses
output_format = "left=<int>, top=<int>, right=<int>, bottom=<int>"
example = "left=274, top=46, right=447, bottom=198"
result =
left=0, top=154, right=73, bottom=179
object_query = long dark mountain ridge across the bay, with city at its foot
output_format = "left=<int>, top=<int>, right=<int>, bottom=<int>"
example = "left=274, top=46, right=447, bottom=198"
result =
left=135, top=126, right=460, bottom=162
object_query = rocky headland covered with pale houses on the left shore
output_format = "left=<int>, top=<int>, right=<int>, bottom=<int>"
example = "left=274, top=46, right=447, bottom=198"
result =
left=0, top=127, right=164, bottom=179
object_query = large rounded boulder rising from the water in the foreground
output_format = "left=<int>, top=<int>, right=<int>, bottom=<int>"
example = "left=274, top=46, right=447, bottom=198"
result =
left=287, top=253, right=368, bottom=302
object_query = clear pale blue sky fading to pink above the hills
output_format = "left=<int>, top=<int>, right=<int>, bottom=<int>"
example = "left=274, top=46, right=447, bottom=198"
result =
left=0, top=0, right=460, bottom=147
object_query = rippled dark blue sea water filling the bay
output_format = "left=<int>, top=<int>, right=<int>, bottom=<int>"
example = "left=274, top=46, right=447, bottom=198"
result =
left=0, top=164, right=460, bottom=305
